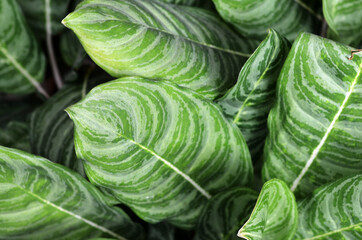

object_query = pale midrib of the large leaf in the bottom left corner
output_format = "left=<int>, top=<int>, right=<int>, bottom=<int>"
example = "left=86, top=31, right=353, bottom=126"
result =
left=11, top=183, right=127, bottom=240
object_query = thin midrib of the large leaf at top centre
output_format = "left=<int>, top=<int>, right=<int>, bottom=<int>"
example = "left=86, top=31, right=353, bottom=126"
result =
left=62, top=16, right=251, bottom=58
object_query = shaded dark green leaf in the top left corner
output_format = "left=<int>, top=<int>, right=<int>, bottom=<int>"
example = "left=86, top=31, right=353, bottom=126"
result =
left=0, top=0, right=47, bottom=96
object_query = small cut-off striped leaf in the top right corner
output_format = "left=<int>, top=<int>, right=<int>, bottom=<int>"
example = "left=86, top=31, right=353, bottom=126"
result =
left=323, top=0, right=362, bottom=46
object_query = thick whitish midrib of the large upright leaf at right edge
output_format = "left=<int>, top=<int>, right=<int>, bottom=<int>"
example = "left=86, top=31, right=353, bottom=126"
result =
left=290, top=63, right=362, bottom=192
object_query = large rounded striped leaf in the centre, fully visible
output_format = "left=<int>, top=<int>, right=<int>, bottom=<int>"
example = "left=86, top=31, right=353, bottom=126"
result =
left=66, top=77, right=252, bottom=229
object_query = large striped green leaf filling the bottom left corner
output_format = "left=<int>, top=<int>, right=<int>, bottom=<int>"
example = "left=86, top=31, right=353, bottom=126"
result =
left=0, top=147, right=142, bottom=240
